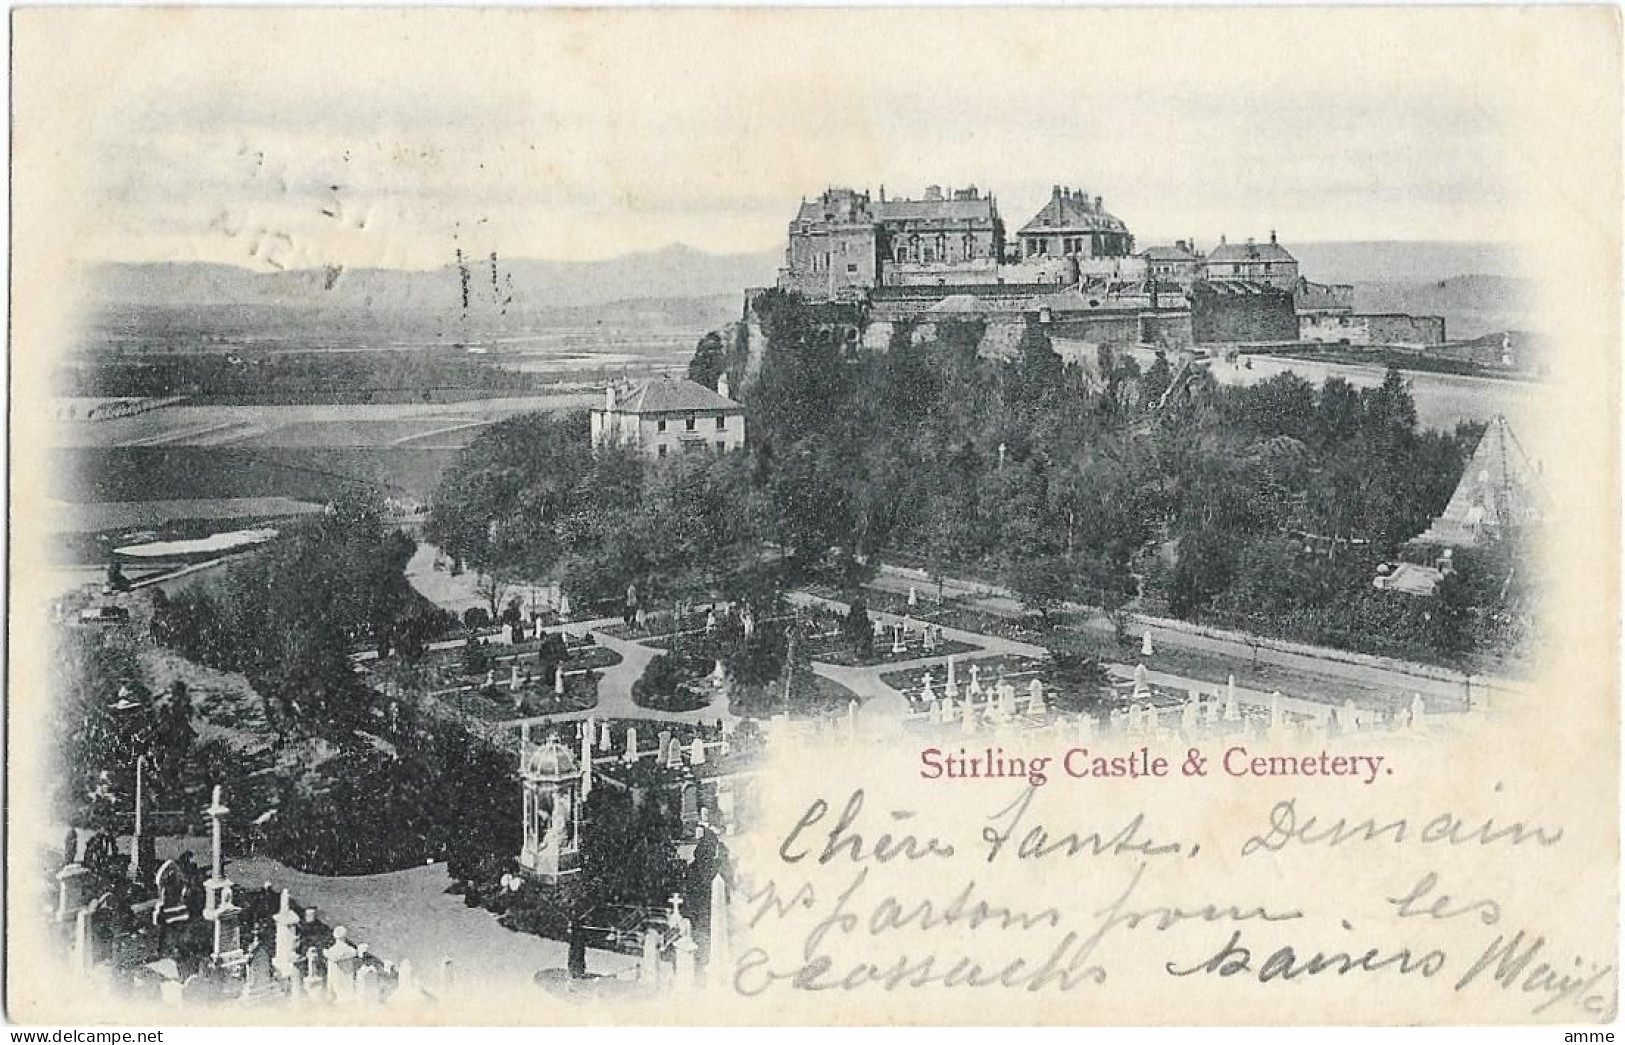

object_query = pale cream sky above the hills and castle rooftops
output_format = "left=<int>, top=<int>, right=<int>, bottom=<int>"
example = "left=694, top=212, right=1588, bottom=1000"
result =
left=16, top=10, right=1540, bottom=270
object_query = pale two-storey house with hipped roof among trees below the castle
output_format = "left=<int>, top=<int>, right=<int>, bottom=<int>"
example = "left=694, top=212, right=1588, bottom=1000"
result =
left=592, top=374, right=744, bottom=457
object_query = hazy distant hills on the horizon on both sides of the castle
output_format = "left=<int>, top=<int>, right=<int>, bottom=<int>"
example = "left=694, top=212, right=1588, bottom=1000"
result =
left=89, top=241, right=1532, bottom=341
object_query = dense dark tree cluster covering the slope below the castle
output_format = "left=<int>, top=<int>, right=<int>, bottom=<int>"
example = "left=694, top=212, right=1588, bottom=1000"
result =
left=429, top=291, right=1511, bottom=669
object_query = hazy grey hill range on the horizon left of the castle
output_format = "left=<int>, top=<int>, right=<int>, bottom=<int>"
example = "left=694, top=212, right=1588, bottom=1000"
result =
left=89, top=245, right=780, bottom=315
